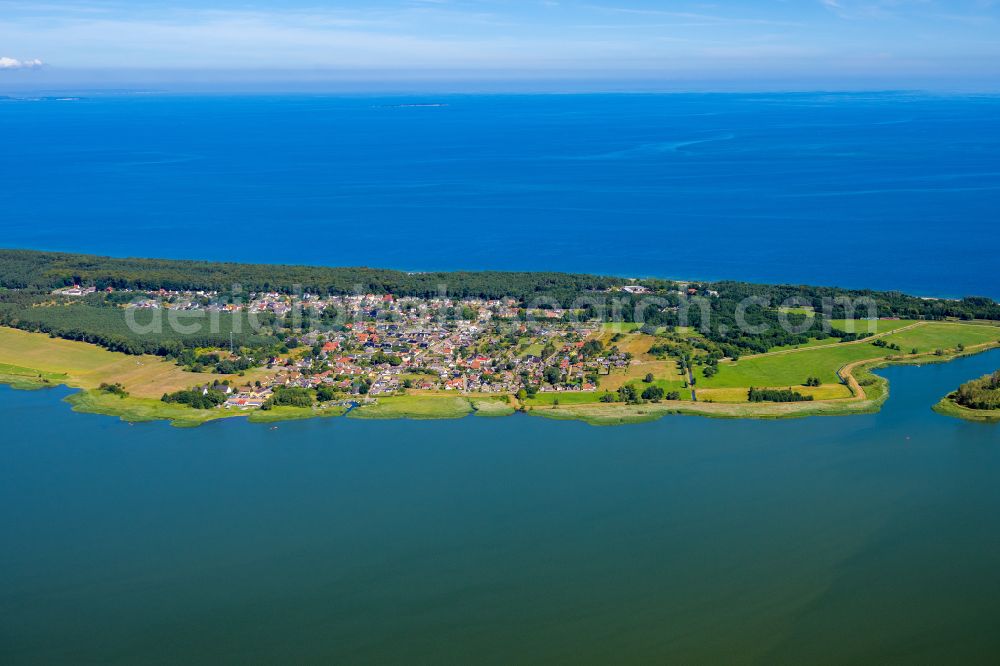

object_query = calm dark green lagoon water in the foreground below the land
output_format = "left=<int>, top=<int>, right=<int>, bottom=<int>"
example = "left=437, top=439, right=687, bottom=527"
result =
left=0, top=352, right=1000, bottom=664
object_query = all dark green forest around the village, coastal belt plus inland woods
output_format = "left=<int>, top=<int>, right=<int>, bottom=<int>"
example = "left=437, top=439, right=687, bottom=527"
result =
left=0, top=250, right=1000, bottom=358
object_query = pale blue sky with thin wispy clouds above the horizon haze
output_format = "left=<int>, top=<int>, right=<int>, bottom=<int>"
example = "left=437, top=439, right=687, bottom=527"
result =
left=0, top=0, right=1000, bottom=86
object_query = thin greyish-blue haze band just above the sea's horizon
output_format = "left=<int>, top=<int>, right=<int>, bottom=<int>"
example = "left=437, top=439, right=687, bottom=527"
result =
left=0, top=67, right=1000, bottom=95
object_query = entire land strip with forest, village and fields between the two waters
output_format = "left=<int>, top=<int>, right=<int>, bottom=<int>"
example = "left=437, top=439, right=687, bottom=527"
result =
left=0, top=250, right=1000, bottom=426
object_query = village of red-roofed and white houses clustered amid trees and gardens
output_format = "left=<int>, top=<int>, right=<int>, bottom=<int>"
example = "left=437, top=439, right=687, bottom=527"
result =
left=50, top=286, right=642, bottom=409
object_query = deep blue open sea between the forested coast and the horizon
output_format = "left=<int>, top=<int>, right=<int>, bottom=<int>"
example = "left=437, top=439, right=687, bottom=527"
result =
left=0, top=90, right=1000, bottom=297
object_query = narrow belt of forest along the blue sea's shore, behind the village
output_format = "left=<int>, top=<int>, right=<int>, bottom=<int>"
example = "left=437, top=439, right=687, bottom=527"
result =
left=0, top=249, right=1000, bottom=321
